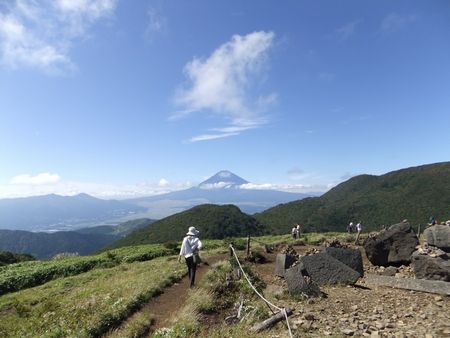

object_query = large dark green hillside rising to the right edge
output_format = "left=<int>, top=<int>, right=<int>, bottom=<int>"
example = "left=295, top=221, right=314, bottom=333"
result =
left=254, top=162, right=450, bottom=233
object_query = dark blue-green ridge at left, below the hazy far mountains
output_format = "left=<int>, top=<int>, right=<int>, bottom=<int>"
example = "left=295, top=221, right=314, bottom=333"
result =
left=0, top=219, right=153, bottom=259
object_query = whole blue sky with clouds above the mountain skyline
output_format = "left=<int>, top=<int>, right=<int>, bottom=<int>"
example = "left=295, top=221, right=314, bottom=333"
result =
left=0, top=0, right=450, bottom=198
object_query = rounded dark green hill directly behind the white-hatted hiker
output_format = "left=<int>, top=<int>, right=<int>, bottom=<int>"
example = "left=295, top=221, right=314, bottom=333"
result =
left=107, top=204, right=267, bottom=249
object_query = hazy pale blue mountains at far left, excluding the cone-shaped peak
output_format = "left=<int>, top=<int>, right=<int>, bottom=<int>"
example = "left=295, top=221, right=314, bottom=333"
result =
left=0, top=194, right=146, bottom=231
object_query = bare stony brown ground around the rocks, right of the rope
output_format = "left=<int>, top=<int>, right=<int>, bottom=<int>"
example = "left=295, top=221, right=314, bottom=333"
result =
left=253, top=246, right=450, bottom=338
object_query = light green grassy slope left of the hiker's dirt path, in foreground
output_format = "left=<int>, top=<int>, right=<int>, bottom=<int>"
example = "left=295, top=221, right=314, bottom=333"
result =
left=0, top=257, right=186, bottom=337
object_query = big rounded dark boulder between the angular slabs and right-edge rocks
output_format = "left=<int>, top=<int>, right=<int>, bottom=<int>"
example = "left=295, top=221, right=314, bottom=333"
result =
left=364, top=222, right=419, bottom=266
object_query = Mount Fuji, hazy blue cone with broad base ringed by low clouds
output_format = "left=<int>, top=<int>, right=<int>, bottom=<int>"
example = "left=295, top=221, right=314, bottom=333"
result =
left=126, top=170, right=316, bottom=218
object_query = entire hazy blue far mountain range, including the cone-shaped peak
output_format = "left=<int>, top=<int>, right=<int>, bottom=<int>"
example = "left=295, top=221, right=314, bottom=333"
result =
left=0, top=170, right=311, bottom=232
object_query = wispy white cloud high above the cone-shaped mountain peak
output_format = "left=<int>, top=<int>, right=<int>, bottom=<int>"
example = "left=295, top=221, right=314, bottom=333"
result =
left=171, top=31, right=277, bottom=142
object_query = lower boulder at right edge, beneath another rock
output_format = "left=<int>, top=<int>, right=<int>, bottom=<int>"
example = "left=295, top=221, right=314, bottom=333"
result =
left=412, top=251, right=450, bottom=282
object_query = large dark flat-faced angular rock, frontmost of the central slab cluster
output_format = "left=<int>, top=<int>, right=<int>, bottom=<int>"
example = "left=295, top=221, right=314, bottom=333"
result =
left=299, top=252, right=360, bottom=285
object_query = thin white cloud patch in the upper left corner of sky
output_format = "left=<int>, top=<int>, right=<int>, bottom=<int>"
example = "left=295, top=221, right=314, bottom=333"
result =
left=0, top=0, right=117, bottom=74
